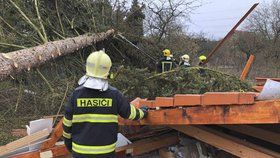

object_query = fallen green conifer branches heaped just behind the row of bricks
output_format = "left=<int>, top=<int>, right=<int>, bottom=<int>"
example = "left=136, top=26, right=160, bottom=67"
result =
left=112, top=67, right=251, bottom=99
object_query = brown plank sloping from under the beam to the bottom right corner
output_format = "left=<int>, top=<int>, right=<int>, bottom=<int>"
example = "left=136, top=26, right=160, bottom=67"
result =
left=171, top=126, right=280, bottom=158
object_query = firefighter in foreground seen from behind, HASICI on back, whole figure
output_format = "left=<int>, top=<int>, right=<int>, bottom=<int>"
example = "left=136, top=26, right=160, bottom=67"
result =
left=63, top=51, right=148, bottom=158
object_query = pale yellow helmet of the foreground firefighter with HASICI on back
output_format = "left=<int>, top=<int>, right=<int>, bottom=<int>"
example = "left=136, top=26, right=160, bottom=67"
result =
left=86, top=51, right=112, bottom=79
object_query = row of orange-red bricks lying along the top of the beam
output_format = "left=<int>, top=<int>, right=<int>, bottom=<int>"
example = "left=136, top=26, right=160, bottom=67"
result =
left=134, top=92, right=256, bottom=109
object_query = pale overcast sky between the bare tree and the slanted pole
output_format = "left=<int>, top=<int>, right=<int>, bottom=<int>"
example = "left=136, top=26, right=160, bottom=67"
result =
left=189, top=0, right=272, bottom=39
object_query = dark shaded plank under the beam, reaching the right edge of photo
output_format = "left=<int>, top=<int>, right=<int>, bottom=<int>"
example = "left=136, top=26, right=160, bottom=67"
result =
left=222, top=125, right=280, bottom=146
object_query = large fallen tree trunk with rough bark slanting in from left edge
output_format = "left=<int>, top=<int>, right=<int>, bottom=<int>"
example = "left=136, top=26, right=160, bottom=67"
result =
left=0, top=30, right=114, bottom=81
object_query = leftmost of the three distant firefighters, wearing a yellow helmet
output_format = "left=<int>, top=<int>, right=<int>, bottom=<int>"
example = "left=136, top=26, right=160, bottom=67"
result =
left=157, top=49, right=176, bottom=73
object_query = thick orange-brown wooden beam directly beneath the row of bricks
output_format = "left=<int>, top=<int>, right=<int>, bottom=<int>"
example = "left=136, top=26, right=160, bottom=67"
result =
left=119, top=100, right=280, bottom=125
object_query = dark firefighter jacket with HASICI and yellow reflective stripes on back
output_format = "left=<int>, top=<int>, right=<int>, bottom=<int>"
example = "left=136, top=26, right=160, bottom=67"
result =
left=63, top=86, right=144, bottom=158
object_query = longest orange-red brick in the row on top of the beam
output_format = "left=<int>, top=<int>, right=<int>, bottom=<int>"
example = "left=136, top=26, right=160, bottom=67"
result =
left=202, top=92, right=239, bottom=105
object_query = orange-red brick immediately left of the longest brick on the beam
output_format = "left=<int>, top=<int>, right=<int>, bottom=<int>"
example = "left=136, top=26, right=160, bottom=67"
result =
left=174, top=94, right=202, bottom=106
